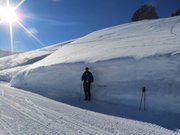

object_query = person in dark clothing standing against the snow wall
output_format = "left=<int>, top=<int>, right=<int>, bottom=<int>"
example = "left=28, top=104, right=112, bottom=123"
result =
left=81, top=67, right=94, bottom=101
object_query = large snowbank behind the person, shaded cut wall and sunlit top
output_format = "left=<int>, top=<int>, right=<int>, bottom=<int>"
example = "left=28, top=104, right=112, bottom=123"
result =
left=8, top=17, right=180, bottom=113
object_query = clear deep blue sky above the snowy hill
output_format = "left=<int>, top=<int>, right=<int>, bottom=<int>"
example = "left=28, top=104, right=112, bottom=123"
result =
left=0, top=0, right=180, bottom=51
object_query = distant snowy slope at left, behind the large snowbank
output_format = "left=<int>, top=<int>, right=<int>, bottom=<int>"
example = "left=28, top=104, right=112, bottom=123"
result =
left=0, top=41, right=72, bottom=82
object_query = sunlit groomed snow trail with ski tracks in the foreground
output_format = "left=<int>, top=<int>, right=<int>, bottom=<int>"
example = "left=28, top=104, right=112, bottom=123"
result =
left=0, top=84, right=178, bottom=135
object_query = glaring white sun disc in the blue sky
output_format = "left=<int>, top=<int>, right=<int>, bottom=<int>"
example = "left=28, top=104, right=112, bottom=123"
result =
left=0, top=6, right=19, bottom=23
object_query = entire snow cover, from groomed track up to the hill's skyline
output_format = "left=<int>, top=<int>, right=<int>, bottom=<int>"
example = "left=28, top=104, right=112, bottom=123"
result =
left=0, top=17, right=180, bottom=135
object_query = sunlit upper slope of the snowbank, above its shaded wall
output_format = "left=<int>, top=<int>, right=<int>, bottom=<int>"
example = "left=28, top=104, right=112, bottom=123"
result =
left=32, top=17, right=180, bottom=65
